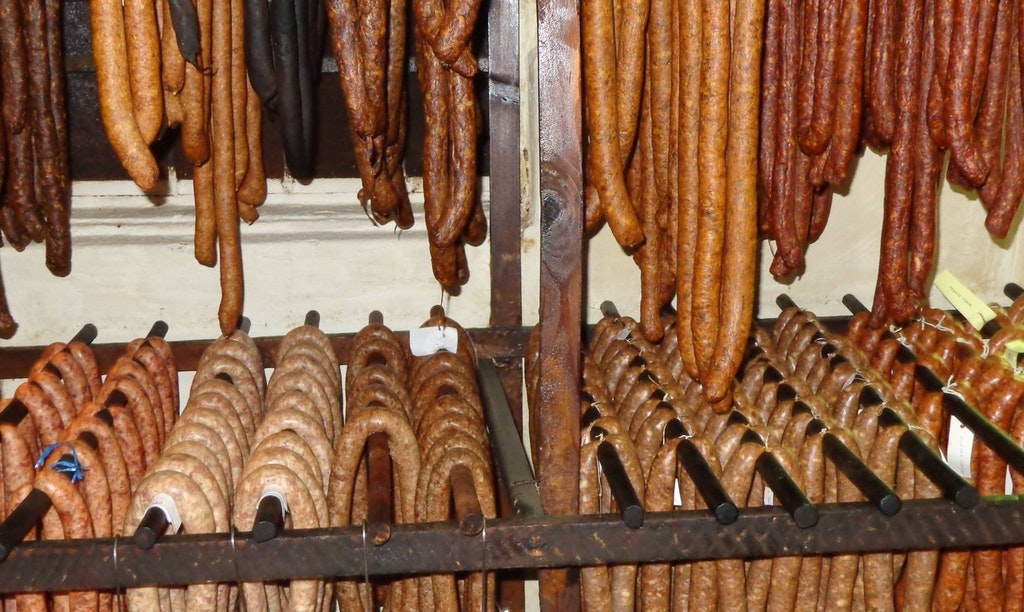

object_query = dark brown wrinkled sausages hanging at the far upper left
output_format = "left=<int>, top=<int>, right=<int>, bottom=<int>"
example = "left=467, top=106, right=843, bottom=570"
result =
left=0, top=0, right=72, bottom=339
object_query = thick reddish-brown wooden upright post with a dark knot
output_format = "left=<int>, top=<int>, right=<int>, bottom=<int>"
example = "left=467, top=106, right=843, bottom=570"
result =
left=530, top=0, right=583, bottom=611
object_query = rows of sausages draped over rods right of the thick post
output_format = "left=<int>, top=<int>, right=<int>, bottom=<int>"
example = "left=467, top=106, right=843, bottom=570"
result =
left=552, top=301, right=1024, bottom=610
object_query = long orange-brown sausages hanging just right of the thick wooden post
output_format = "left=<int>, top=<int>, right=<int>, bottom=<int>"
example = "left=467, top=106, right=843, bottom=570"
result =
left=581, top=0, right=765, bottom=406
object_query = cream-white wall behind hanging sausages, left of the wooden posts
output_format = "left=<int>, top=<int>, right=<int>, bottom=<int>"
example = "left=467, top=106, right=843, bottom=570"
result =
left=0, top=179, right=489, bottom=345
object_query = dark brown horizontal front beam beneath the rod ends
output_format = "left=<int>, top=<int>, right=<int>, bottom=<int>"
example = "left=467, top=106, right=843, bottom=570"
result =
left=0, top=496, right=1024, bottom=593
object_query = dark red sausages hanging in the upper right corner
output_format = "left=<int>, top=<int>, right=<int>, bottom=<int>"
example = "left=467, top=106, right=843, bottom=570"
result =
left=759, top=0, right=1024, bottom=326
